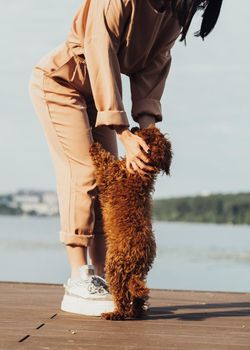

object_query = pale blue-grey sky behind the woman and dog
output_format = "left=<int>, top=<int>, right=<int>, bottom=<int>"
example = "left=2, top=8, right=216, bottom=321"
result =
left=0, top=0, right=250, bottom=198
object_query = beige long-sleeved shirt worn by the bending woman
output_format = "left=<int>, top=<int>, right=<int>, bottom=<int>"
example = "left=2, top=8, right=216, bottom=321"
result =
left=67, top=0, right=181, bottom=127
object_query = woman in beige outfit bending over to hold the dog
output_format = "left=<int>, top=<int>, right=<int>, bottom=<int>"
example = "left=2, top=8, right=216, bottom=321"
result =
left=29, top=0, right=222, bottom=315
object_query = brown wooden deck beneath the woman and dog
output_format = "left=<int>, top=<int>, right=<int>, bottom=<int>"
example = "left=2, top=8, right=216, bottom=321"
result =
left=0, top=282, right=250, bottom=350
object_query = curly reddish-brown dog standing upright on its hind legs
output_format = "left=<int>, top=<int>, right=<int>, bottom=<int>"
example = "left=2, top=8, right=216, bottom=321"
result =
left=90, top=124, right=172, bottom=320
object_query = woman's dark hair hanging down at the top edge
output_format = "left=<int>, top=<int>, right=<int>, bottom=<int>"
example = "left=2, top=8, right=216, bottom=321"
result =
left=171, top=0, right=223, bottom=42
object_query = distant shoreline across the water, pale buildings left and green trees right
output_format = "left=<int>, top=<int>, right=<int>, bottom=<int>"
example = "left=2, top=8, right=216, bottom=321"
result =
left=0, top=191, right=250, bottom=225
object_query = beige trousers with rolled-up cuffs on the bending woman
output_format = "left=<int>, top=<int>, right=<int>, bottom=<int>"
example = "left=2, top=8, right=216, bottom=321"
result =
left=29, top=43, right=118, bottom=246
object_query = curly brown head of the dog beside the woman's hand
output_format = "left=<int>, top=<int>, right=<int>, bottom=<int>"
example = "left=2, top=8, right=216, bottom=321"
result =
left=131, top=124, right=173, bottom=175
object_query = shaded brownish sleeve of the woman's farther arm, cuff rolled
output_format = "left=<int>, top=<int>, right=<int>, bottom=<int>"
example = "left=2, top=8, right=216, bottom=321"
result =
left=129, top=49, right=172, bottom=122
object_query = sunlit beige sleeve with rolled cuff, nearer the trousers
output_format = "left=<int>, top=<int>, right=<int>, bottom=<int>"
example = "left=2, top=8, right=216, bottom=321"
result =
left=83, top=0, right=130, bottom=128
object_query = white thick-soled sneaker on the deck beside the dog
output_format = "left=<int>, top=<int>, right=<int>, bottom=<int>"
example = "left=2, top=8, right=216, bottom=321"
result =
left=61, top=265, right=115, bottom=316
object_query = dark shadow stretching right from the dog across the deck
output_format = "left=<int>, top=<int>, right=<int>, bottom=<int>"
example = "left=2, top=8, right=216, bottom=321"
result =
left=134, top=302, right=250, bottom=321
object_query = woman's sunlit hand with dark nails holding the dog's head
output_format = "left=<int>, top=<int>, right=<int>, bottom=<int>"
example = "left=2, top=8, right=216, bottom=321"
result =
left=115, top=127, right=154, bottom=175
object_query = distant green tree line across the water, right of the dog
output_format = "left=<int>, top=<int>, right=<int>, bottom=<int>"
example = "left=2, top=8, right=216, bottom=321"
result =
left=153, top=193, right=250, bottom=225
